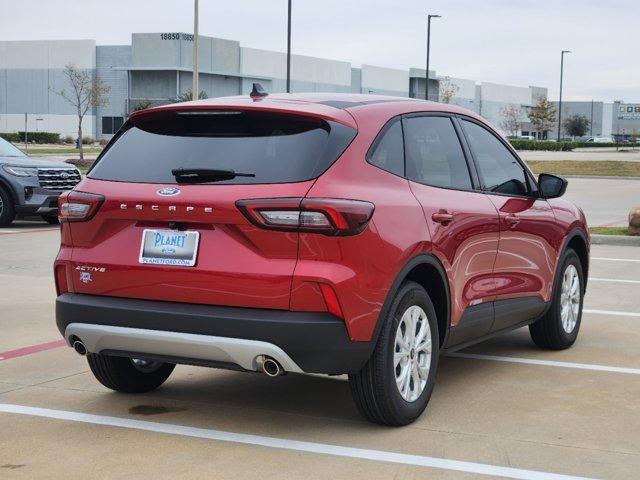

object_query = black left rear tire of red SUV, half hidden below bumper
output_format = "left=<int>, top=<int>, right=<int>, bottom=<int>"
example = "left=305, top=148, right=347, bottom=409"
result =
left=87, top=353, right=175, bottom=393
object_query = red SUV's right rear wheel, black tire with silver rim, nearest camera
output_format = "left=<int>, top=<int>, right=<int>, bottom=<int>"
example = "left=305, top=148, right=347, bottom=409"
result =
left=349, top=282, right=440, bottom=426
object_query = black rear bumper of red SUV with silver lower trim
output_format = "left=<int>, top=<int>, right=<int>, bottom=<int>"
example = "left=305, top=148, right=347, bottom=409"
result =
left=56, top=293, right=373, bottom=374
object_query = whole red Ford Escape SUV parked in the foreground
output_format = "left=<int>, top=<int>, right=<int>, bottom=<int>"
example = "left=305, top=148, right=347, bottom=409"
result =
left=55, top=94, right=589, bottom=425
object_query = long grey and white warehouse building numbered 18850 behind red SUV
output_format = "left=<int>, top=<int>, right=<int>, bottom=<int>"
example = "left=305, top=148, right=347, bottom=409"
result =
left=0, top=32, right=560, bottom=140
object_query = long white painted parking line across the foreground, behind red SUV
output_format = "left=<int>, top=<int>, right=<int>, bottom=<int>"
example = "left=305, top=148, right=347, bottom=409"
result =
left=0, top=403, right=586, bottom=480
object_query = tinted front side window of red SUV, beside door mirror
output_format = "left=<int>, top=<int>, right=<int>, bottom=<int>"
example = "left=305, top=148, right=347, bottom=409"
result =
left=462, top=120, right=529, bottom=195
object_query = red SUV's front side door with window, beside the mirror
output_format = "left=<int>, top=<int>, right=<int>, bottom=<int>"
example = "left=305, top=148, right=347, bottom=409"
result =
left=460, top=119, right=558, bottom=330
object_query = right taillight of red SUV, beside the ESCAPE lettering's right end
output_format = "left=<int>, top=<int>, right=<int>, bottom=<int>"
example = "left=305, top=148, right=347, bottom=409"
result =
left=236, top=198, right=374, bottom=236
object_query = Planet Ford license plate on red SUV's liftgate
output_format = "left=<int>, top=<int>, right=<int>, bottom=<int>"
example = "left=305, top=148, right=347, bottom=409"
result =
left=139, top=229, right=200, bottom=267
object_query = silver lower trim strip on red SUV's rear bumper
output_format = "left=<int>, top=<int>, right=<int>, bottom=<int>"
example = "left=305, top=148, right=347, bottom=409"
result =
left=64, top=323, right=302, bottom=373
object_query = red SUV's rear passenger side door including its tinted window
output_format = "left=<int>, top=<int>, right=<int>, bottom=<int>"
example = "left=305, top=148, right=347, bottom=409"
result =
left=403, top=114, right=499, bottom=345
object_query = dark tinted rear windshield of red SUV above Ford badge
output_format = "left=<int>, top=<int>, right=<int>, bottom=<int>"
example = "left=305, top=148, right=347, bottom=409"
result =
left=88, top=110, right=356, bottom=184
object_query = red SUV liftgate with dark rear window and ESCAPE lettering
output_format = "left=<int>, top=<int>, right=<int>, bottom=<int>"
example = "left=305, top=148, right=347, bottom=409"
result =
left=70, top=111, right=355, bottom=309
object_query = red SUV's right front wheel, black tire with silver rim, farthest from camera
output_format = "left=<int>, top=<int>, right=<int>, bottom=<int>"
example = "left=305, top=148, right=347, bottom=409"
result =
left=529, top=249, right=584, bottom=350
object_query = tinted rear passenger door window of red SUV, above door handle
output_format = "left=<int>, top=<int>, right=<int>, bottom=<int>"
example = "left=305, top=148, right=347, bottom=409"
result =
left=404, top=117, right=472, bottom=190
